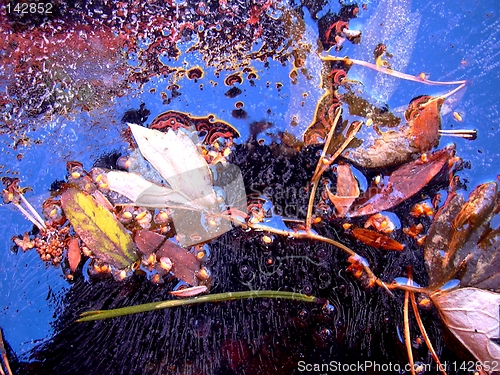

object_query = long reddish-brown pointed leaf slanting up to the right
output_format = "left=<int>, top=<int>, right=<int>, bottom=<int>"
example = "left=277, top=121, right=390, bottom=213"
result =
left=349, top=146, right=455, bottom=217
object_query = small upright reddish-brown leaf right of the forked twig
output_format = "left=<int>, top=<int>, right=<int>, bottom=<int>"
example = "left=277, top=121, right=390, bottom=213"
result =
left=326, top=164, right=359, bottom=217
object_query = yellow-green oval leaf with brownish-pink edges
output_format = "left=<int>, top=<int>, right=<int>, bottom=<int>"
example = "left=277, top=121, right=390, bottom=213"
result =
left=61, top=188, right=137, bottom=269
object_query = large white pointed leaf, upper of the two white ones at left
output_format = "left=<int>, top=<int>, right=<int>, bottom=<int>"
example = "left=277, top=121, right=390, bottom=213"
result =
left=129, top=124, right=217, bottom=210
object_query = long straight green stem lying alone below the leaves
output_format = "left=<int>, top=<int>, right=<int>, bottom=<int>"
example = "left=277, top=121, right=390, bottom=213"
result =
left=77, top=290, right=327, bottom=322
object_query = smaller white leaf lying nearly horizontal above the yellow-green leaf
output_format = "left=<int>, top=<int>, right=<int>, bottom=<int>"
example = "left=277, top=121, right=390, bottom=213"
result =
left=106, top=171, right=190, bottom=208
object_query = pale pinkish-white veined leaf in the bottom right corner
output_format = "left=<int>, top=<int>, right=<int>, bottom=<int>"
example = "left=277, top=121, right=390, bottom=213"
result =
left=432, top=288, right=500, bottom=362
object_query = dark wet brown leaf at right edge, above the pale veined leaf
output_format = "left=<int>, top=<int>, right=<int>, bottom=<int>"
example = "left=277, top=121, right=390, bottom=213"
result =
left=424, top=182, right=500, bottom=292
